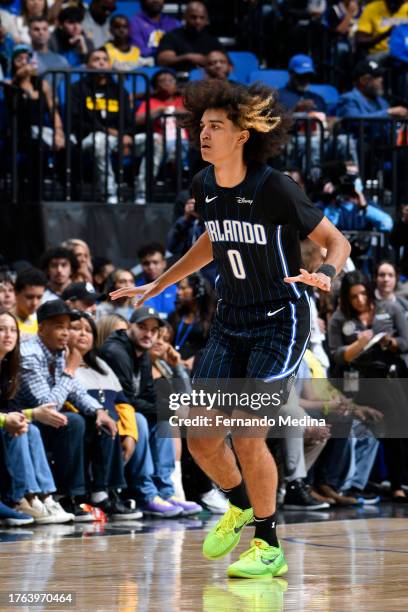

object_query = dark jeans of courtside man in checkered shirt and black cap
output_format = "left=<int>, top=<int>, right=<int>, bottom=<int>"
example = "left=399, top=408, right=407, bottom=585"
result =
left=38, top=412, right=85, bottom=497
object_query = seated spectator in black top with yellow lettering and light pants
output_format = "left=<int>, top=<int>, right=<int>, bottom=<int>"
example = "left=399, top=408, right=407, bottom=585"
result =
left=72, top=47, right=136, bottom=204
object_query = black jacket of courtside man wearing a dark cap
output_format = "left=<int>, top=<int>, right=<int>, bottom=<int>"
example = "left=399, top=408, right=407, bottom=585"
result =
left=101, top=329, right=156, bottom=417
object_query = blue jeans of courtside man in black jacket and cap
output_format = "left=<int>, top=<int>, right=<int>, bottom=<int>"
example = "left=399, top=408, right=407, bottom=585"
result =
left=125, top=412, right=175, bottom=505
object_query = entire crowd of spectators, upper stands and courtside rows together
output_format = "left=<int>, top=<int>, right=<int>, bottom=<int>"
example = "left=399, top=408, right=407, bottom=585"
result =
left=0, top=0, right=408, bottom=525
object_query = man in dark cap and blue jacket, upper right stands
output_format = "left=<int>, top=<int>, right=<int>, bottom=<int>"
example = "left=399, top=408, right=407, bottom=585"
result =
left=337, top=60, right=408, bottom=119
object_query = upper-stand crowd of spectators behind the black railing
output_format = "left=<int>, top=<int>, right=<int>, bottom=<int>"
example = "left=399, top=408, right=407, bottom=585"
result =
left=0, top=0, right=408, bottom=204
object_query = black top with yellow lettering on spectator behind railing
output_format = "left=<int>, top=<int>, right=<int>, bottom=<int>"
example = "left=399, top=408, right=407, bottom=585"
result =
left=72, top=74, right=135, bottom=140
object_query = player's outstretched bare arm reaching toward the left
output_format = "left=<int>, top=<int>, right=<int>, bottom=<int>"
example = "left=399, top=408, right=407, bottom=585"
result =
left=109, top=232, right=213, bottom=307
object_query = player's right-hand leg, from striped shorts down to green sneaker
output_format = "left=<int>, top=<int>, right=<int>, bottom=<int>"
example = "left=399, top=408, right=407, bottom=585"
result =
left=228, top=295, right=310, bottom=577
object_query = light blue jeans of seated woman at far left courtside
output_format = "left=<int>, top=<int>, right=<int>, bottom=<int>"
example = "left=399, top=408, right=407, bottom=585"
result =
left=2, top=424, right=56, bottom=503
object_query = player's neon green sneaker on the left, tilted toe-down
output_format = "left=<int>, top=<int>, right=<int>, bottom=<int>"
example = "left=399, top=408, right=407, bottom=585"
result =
left=203, top=502, right=254, bottom=559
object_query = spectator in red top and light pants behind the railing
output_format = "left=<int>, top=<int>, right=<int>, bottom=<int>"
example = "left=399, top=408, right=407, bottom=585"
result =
left=136, top=69, right=189, bottom=194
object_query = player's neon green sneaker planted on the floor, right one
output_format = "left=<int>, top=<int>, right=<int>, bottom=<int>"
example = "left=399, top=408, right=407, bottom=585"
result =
left=227, top=538, right=288, bottom=578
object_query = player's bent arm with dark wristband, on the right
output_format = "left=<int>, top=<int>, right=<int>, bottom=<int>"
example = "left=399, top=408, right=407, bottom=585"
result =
left=285, top=217, right=351, bottom=291
